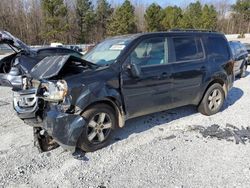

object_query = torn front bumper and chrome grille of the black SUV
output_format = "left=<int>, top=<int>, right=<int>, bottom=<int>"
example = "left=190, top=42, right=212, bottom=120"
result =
left=13, top=89, right=86, bottom=152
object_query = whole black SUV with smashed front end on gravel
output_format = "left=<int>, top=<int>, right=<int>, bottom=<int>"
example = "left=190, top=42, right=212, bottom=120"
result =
left=11, top=31, right=234, bottom=151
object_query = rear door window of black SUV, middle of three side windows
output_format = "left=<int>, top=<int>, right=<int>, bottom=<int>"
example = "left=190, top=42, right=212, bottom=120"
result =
left=173, top=37, right=204, bottom=62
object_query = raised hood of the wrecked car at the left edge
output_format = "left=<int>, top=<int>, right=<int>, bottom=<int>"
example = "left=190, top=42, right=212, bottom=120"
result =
left=0, top=31, right=30, bottom=52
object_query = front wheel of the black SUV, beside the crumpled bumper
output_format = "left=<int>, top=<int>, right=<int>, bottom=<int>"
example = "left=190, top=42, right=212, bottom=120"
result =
left=77, top=104, right=117, bottom=152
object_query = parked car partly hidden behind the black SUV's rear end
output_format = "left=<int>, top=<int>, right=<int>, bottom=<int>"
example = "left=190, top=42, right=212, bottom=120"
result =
left=229, top=41, right=248, bottom=77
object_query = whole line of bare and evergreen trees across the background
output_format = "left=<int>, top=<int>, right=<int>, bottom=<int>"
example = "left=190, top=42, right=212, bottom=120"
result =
left=0, top=0, right=250, bottom=45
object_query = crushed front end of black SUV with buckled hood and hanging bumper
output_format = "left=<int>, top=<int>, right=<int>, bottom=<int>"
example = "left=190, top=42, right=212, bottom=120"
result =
left=13, top=56, right=99, bottom=152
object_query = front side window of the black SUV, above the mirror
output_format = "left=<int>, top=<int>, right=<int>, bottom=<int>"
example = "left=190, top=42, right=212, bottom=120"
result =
left=130, top=37, right=167, bottom=67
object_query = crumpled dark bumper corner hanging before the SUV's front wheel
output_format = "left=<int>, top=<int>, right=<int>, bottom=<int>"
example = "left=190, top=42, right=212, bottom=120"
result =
left=42, top=107, right=86, bottom=152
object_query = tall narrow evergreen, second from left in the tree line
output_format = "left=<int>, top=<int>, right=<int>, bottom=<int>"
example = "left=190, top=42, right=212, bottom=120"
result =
left=76, top=0, right=95, bottom=43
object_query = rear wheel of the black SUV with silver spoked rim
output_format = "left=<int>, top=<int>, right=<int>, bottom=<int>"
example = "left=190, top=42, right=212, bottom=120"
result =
left=198, top=83, right=225, bottom=116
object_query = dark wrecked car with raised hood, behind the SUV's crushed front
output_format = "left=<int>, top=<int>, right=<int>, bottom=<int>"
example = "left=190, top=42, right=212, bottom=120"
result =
left=0, top=31, right=82, bottom=89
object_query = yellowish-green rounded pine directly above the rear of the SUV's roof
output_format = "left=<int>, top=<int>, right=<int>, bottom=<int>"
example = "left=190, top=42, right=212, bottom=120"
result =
left=201, top=5, right=218, bottom=30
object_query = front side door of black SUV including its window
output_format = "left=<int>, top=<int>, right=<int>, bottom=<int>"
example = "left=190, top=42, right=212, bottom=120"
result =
left=121, top=37, right=172, bottom=117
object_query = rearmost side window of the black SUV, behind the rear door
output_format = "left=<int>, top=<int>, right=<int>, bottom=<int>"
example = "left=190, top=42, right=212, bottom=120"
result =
left=206, top=37, right=229, bottom=60
